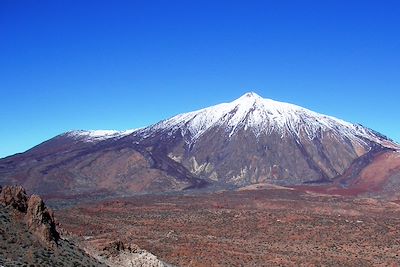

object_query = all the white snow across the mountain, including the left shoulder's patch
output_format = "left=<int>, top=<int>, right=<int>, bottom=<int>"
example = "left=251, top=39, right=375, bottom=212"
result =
left=57, top=92, right=399, bottom=152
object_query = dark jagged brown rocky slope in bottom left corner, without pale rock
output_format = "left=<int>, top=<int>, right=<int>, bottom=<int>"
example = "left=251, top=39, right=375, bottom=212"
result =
left=0, top=186, right=106, bottom=266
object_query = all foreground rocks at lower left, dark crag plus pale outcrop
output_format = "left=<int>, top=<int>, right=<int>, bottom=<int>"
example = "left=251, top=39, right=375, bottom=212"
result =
left=0, top=186, right=170, bottom=267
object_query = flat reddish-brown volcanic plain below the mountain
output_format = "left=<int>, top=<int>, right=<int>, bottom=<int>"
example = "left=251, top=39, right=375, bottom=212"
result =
left=56, top=189, right=400, bottom=266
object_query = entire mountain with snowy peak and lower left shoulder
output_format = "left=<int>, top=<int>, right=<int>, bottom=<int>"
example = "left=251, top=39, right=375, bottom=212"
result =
left=0, top=93, right=400, bottom=198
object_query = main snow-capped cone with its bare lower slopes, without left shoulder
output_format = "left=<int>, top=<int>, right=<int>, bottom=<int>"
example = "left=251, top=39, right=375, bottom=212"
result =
left=129, top=93, right=397, bottom=186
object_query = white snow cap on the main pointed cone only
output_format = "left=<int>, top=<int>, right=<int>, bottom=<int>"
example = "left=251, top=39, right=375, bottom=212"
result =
left=142, top=92, right=394, bottom=149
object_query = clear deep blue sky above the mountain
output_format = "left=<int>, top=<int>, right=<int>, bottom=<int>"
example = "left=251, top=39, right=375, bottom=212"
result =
left=0, top=0, right=400, bottom=157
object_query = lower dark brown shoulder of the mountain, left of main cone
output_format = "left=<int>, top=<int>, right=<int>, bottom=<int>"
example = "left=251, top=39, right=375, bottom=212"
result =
left=0, top=131, right=204, bottom=196
